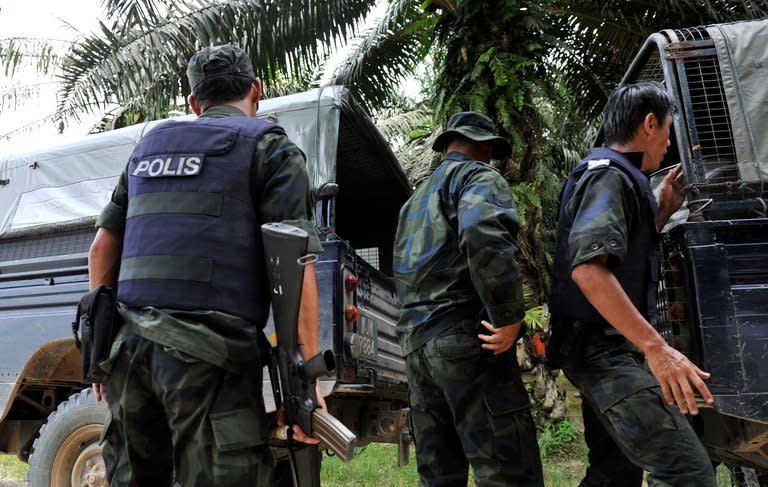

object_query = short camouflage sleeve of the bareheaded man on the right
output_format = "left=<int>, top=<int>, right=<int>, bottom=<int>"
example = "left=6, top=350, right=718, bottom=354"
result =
left=566, top=167, right=638, bottom=267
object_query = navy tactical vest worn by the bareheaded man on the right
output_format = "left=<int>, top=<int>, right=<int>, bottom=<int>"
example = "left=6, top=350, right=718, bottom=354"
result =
left=550, top=147, right=659, bottom=334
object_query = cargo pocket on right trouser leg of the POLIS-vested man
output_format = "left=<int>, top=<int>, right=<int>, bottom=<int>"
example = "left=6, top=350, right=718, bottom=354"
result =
left=210, top=408, right=269, bottom=452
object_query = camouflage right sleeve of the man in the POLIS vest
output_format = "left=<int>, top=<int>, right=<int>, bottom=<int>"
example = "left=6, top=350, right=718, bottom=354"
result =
left=254, top=134, right=323, bottom=253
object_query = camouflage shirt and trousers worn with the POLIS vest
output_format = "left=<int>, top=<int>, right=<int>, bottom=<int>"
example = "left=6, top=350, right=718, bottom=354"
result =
left=97, top=106, right=322, bottom=487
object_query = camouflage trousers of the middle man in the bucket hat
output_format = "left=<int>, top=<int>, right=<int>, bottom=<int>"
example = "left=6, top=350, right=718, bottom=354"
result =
left=406, top=331, right=544, bottom=487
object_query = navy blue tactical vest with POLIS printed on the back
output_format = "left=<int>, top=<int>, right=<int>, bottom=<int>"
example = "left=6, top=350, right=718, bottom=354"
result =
left=118, top=116, right=284, bottom=326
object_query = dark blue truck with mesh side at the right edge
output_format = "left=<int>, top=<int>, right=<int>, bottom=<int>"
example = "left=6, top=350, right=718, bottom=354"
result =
left=622, top=20, right=768, bottom=485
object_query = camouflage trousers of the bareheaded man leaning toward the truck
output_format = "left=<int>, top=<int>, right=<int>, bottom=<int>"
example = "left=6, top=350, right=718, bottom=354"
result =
left=564, top=338, right=716, bottom=487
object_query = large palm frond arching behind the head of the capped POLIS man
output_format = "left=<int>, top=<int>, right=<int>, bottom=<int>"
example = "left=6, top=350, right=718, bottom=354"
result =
left=58, top=0, right=373, bottom=124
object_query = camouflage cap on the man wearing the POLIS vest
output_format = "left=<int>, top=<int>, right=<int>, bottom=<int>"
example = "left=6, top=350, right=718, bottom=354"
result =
left=187, top=44, right=256, bottom=88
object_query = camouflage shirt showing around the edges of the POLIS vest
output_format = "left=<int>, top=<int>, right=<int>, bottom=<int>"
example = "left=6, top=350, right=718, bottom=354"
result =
left=96, top=106, right=323, bottom=370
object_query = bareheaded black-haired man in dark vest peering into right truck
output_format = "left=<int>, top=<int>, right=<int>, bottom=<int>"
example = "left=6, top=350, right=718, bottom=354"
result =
left=548, top=82, right=716, bottom=487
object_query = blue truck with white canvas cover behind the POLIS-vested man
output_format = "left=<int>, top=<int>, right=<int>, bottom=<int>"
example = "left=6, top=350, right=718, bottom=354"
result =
left=0, top=86, right=411, bottom=487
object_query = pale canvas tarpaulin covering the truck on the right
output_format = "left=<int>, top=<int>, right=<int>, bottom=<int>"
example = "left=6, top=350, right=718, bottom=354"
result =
left=707, top=20, right=768, bottom=184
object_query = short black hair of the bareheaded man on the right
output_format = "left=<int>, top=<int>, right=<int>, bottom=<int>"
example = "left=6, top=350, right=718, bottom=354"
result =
left=603, top=81, right=675, bottom=145
